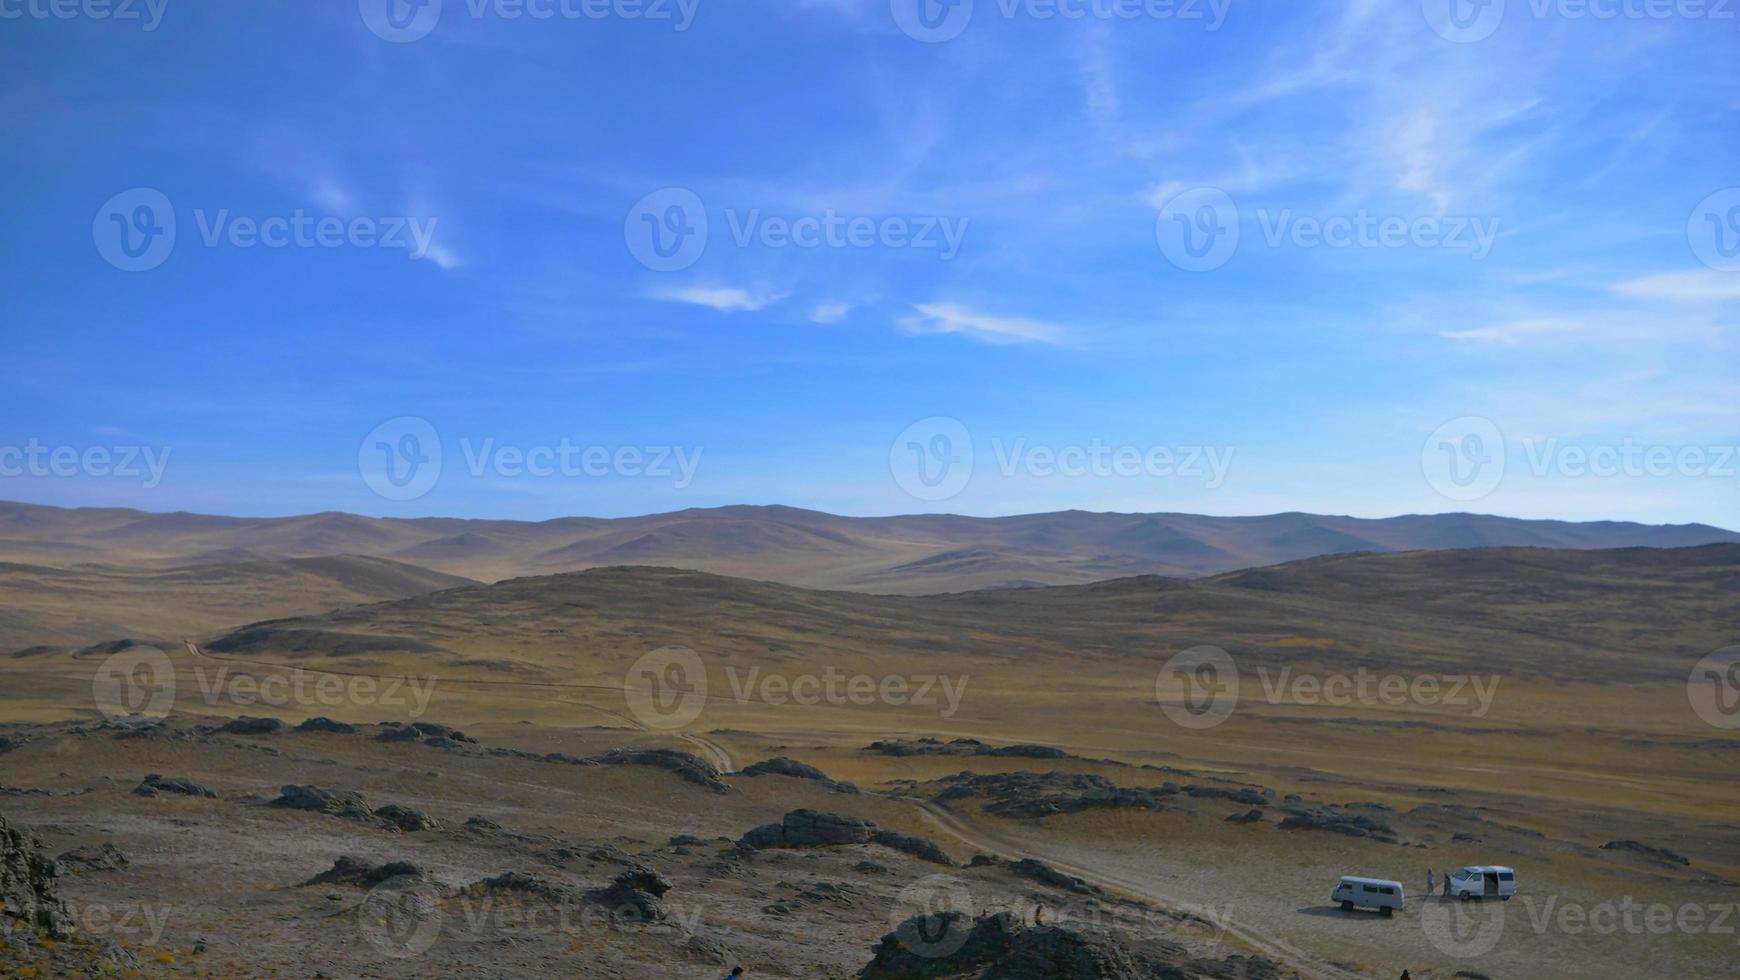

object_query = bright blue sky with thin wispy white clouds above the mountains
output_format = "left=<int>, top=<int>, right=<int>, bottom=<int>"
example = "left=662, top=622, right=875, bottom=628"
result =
left=0, top=0, right=1740, bottom=527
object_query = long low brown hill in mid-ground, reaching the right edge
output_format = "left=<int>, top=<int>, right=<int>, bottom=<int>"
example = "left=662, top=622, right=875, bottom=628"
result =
left=194, top=545, right=1740, bottom=682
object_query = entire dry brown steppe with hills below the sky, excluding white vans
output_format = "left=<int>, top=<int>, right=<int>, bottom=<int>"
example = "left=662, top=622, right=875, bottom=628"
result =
left=0, top=508, right=1740, bottom=978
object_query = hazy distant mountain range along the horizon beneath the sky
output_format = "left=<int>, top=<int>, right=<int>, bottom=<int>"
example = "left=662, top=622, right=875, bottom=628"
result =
left=0, top=503, right=1740, bottom=594
